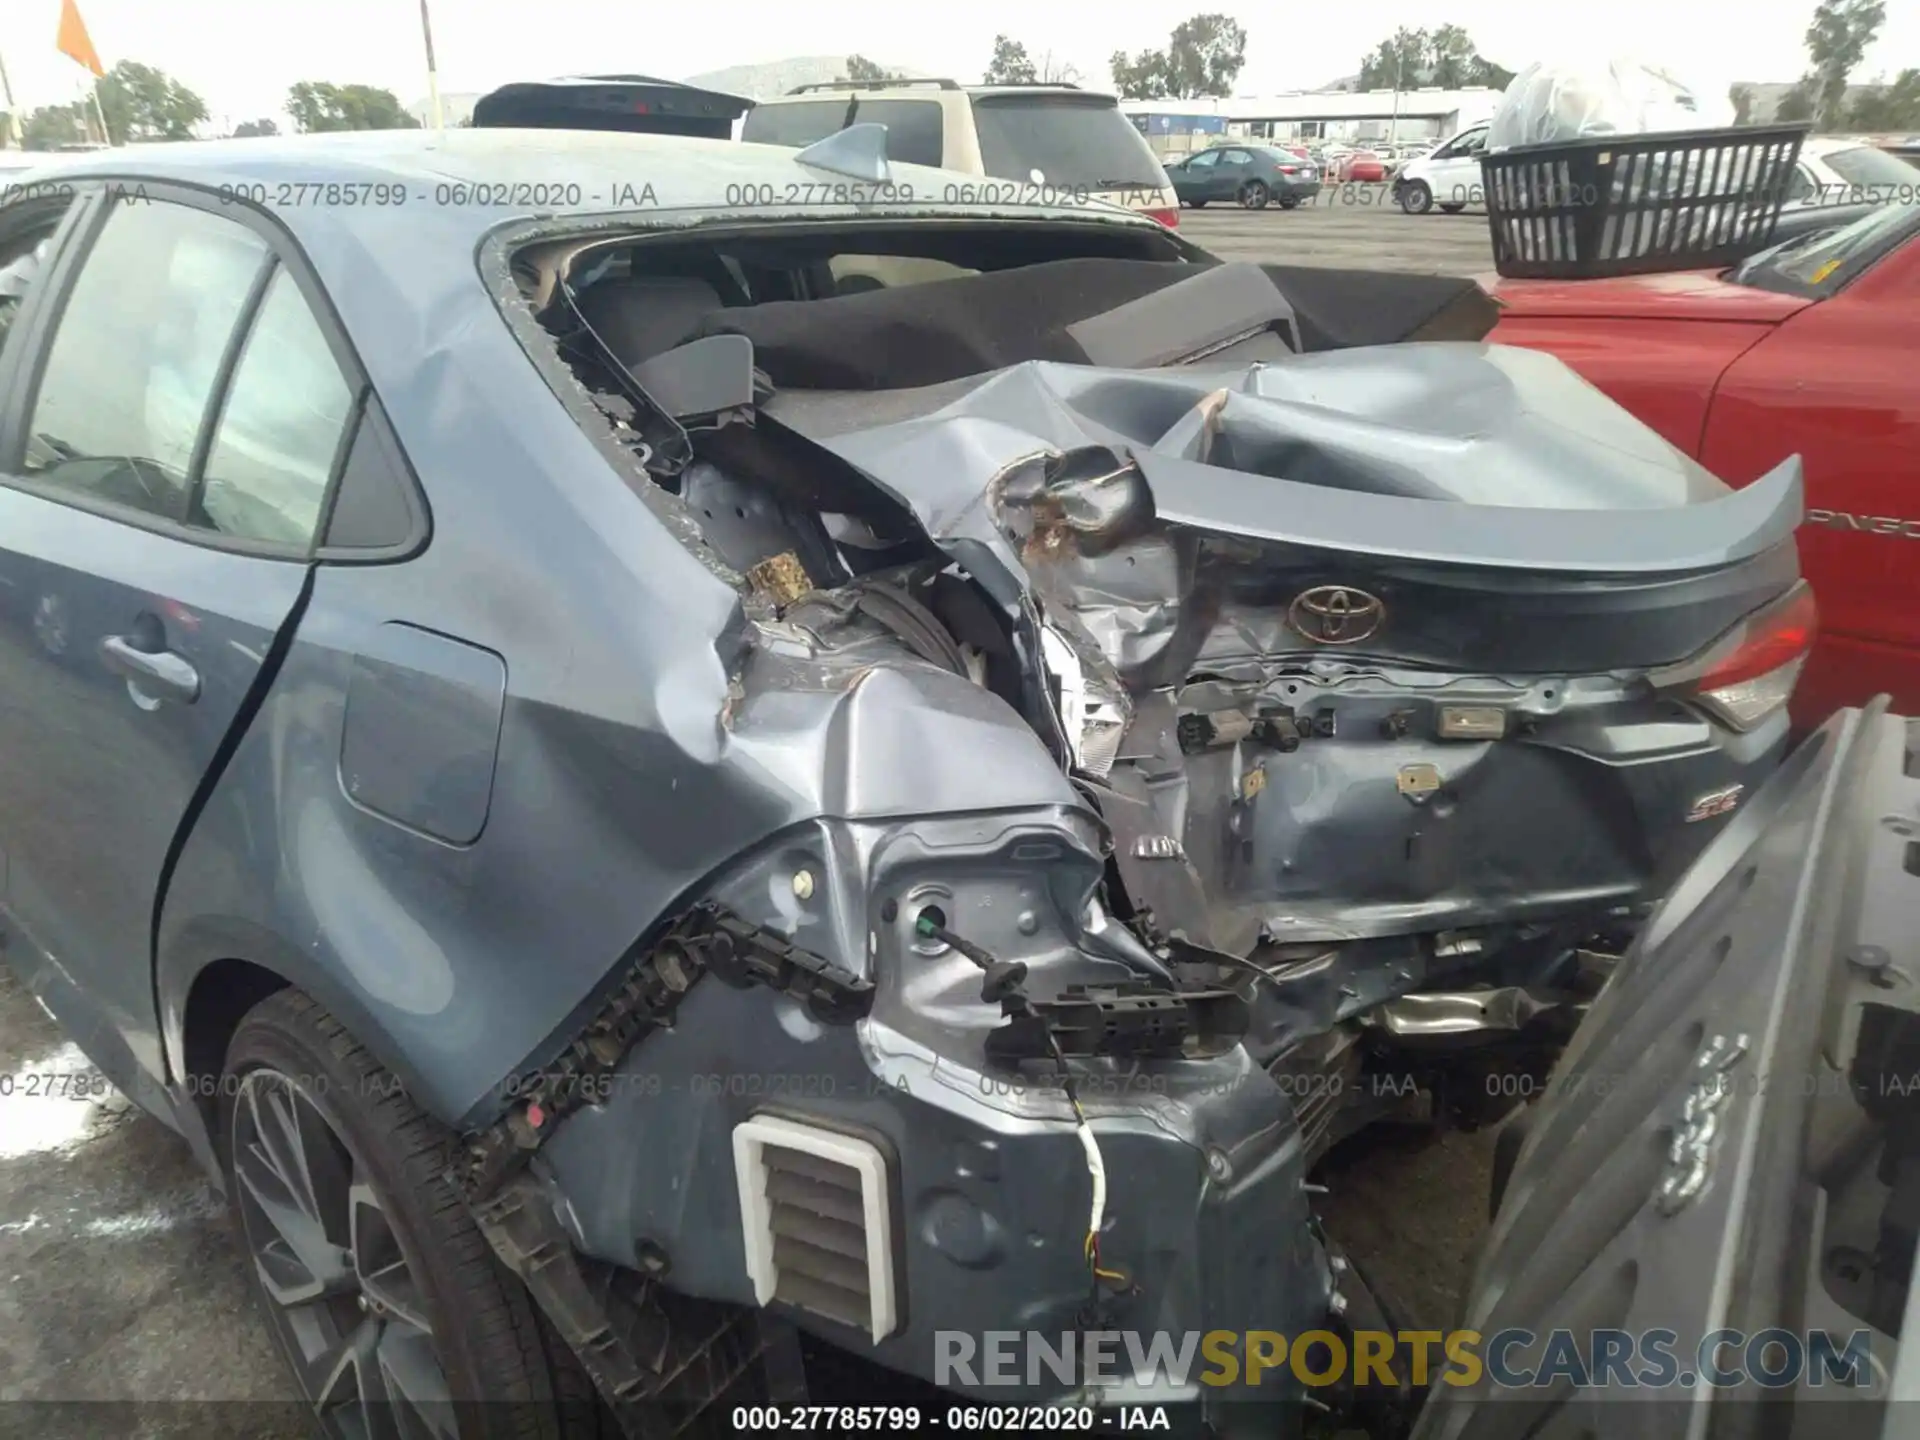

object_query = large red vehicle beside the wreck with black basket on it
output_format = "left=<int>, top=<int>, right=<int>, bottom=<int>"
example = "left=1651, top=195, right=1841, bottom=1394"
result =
left=1484, top=205, right=1920, bottom=724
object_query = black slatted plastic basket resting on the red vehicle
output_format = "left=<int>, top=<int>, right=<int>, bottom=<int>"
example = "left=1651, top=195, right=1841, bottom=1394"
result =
left=1480, top=125, right=1809, bottom=280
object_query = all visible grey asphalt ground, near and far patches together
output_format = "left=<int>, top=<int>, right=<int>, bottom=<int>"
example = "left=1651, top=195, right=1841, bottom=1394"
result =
left=0, top=186, right=1490, bottom=1440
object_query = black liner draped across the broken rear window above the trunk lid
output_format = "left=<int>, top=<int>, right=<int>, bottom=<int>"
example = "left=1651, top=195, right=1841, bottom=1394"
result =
left=689, top=257, right=1498, bottom=390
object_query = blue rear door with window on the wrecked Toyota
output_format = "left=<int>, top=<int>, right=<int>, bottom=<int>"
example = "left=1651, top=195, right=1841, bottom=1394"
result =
left=0, top=188, right=355, bottom=1096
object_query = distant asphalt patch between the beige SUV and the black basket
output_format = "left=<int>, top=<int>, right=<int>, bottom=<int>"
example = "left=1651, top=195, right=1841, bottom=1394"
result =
left=1181, top=184, right=1494, bottom=275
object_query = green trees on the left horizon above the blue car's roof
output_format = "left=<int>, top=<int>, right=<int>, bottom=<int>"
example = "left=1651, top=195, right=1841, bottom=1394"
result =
left=0, top=60, right=420, bottom=150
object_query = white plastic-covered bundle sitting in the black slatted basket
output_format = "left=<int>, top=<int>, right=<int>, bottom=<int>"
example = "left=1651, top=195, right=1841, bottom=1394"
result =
left=1486, top=58, right=1734, bottom=150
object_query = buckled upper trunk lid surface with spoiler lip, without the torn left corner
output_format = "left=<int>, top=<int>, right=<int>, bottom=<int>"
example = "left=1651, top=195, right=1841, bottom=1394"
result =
left=774, top=344, right=1801, bottom=574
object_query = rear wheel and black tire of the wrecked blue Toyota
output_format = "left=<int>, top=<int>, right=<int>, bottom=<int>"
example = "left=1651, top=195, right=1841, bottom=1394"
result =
left=219, top=991, right=614, bottom=1440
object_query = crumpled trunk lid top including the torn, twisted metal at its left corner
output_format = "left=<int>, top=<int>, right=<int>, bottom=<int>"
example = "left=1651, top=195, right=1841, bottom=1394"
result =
left=780, top=344, right=1801, bottom=703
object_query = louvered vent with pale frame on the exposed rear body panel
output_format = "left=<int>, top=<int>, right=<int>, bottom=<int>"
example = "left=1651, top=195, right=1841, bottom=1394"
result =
left=733, top=1116, right=897, bottom=1344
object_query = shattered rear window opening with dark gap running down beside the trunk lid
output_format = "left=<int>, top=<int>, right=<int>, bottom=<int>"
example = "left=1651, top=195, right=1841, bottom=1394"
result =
left=511, top=221, right=1210, bottom=705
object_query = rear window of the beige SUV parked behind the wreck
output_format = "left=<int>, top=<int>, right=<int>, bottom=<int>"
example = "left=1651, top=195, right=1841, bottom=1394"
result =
left=973, top=94, right=1165, bottom=190
